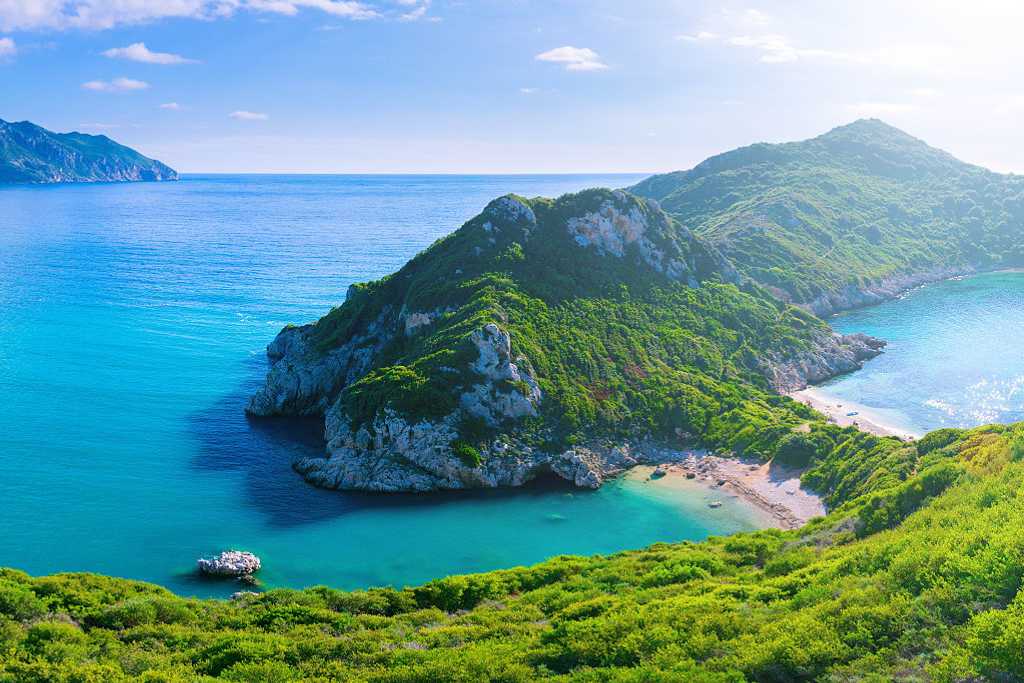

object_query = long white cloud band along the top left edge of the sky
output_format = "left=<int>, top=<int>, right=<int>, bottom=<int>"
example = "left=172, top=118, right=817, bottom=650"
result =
left=0, top=0, right=381, bottom=31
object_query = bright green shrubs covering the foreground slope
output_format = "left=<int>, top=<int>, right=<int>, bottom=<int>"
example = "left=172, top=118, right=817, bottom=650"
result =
left=6, top=425, right=1024, bottom=683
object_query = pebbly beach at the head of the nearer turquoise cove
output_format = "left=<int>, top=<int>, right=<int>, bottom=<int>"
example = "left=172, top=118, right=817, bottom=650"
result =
left=633, top=451, right=827, bottom=529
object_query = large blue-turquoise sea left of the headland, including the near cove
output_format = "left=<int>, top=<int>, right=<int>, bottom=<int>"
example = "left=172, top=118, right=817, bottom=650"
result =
left=0, top=176, right=770, bottom=595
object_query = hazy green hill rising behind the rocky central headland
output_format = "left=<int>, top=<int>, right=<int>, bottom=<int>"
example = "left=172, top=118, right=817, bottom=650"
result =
left=631, top=120, right=1024, bottom=313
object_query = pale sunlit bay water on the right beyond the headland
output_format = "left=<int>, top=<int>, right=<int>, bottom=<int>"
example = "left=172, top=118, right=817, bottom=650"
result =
left=823, top=271, right=1024, bottom=433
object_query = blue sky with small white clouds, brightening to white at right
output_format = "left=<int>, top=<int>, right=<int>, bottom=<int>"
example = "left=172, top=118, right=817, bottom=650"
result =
left=0, top=0, right=1024, bottom=173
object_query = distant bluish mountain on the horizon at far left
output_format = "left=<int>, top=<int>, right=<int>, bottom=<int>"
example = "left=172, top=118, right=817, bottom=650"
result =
left=0, top=119, right=178, bottom=183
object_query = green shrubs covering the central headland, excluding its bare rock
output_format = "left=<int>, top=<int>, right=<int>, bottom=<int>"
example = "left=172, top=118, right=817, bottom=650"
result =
left=314, top=189, right=827, bottom=459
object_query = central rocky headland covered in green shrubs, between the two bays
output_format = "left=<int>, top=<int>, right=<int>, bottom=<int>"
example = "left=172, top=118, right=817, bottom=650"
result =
left=248, top=190, right=876, bottom=492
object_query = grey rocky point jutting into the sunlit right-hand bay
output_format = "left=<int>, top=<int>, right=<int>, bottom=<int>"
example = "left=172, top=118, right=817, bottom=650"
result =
left=761, top=331, right=886, bottom=393
